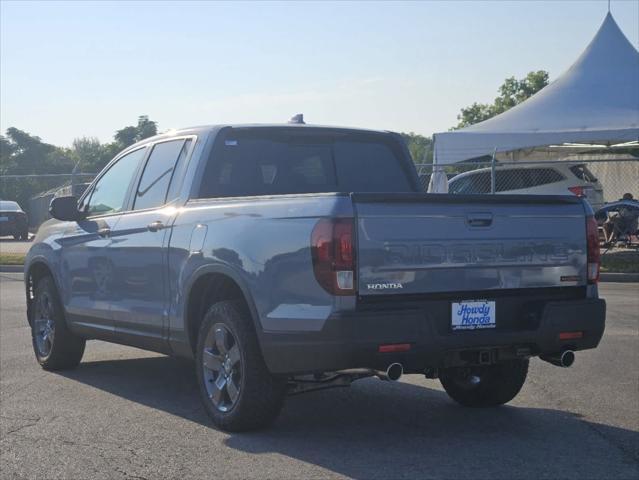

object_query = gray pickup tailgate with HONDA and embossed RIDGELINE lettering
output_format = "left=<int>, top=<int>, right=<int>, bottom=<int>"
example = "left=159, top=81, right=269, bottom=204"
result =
left=352, top=193, right=587, bottom=296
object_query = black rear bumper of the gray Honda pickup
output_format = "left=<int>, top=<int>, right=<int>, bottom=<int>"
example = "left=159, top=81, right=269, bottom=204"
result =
left=261, top=299, right=606, bottom=374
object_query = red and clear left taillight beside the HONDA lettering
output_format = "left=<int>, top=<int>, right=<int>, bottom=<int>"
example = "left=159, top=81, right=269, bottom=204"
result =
left=311, top=218, right=355, bottom=295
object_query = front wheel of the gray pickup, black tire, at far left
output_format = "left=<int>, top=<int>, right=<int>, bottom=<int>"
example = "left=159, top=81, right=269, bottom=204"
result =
left=29, top=276, right=86, bottom=370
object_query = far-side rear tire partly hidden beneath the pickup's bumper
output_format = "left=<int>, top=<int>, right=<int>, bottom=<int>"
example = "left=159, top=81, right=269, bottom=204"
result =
left=439, top=360, right=528, bottom=407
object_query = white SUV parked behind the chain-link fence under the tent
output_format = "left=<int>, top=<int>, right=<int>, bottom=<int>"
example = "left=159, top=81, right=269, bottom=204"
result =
left=448, top=163, right=604, bottom=211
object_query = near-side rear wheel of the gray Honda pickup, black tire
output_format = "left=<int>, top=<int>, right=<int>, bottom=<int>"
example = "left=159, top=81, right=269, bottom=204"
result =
left=195, top=301, right=286, bottom=432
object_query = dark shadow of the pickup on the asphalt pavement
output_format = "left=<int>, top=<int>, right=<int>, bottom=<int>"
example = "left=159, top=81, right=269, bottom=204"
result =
left=63, top=357, right=639, bottom=479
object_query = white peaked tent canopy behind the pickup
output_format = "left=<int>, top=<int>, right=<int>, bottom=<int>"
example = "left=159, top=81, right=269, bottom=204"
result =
left=429, top=13, right=639, bottom=171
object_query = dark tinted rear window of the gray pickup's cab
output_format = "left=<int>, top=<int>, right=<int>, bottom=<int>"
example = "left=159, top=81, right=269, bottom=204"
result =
left=199, top=129, right=414, bottom=198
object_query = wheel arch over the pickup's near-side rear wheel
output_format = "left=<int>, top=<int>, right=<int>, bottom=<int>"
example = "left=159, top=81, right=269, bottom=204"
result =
left=183, top=265, right=261, bottom=354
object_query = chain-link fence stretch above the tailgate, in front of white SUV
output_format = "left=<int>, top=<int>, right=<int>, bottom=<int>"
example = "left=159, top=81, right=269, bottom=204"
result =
left=416, top=158, right=639, bottom=208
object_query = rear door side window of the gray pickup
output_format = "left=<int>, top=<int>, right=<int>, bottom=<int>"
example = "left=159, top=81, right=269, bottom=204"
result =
left=133, top=139, right=190, bottom=210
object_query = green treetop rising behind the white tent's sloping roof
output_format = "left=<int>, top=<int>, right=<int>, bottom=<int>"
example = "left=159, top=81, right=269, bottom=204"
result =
left=455, top=70, right=549, bottom=128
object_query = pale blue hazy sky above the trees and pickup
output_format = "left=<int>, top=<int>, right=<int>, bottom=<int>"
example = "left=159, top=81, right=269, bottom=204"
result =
left=0, top=0, right=639, bottom=145
